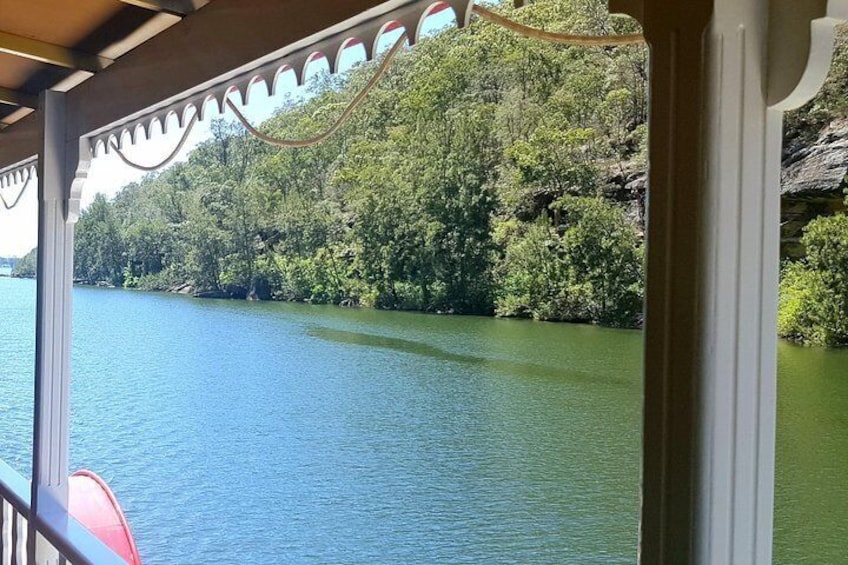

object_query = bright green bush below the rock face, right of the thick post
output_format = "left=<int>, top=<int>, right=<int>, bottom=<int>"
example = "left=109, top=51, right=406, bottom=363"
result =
left=778, top=214, right=848, bottom=346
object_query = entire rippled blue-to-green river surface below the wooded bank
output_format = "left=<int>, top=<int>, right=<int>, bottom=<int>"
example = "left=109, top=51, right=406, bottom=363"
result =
left=0, top=278, right=848, bottom=565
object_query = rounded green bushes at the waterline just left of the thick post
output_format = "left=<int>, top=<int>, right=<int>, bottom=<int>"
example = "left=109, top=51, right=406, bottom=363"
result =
left=497, top=196, right=643, bottom=327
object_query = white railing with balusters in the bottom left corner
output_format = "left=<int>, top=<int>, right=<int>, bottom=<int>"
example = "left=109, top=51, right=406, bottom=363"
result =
left=0, top=461, right=125, bottom=565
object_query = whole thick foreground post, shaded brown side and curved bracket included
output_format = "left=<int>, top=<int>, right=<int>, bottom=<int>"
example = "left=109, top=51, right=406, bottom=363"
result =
left=611, top=0, right=845, bottom=565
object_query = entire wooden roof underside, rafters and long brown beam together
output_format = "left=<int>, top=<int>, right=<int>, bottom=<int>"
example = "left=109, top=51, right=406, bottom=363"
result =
left=0, top=0, right=412, bottom=175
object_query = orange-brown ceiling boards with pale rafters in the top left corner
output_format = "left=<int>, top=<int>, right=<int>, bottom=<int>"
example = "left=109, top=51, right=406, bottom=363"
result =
left=0, top=0, right=209, bottom=129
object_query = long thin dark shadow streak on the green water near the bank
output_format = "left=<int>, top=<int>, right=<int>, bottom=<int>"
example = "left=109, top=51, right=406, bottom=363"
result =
left=307, top=327, right=629, bottom=385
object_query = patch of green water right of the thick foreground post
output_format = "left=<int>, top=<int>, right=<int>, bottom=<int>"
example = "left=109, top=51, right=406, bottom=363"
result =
left=774, top=343, right=848, bottom=565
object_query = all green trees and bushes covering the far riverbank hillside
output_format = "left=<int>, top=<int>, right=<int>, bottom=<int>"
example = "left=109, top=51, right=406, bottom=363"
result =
left=9, top=0, right=848, bottom=345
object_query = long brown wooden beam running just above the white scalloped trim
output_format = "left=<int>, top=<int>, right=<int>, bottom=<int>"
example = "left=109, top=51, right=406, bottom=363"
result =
left=0, top=0, right=400, bottom=168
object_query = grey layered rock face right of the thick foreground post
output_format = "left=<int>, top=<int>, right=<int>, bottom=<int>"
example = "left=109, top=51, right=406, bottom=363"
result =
left=780, top=120, right=848, bottom=258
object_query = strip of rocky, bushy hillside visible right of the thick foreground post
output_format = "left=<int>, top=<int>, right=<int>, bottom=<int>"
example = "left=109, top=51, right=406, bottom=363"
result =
left=778, top=30, right=848, bottom=346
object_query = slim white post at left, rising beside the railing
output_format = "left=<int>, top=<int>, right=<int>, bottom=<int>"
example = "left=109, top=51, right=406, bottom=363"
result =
left=28, top=91, right=90, bottom=564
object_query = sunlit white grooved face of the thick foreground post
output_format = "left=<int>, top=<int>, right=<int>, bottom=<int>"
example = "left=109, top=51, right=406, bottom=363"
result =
left=695, top=0, right=783, bottom=565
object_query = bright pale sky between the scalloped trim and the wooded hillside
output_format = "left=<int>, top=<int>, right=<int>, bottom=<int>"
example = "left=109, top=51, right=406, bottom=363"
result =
left=0, top=19, right=438, bottom=257
